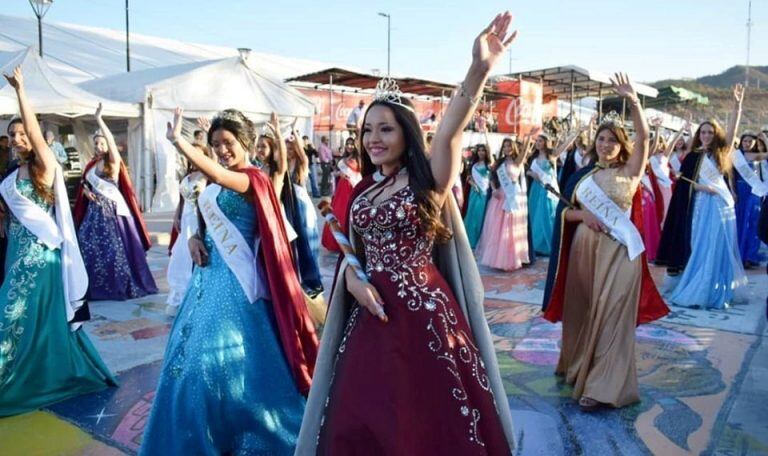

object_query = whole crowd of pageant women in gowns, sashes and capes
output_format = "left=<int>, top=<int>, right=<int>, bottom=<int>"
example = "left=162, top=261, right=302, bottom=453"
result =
left=0, top=8, right=768, bottom=455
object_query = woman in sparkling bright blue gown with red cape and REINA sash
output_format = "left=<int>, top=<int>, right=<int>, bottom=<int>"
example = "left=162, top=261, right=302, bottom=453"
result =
left=141, top=109, right=317, bottom=455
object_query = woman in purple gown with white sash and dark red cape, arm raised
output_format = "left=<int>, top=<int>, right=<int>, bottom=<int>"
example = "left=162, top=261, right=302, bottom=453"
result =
left=75, top=104, right=157, bottom=301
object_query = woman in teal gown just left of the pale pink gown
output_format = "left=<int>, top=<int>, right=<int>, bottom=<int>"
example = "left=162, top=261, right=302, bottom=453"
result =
left=464, top=144, right=492, bottom=250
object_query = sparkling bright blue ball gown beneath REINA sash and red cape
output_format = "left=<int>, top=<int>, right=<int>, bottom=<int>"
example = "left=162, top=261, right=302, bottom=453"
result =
left=141, top=189, right=305, bottom=455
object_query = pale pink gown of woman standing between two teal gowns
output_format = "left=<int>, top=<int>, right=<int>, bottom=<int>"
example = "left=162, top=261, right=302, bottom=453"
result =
left=477, top=162, right=530, bottom=271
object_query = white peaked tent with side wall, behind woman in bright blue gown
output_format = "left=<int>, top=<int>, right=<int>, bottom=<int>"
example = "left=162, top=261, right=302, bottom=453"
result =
left=81, top=55, right=315, bottom=211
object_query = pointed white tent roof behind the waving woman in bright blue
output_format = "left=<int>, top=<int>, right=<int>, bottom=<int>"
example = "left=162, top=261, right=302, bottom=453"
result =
left=80, top=56, right=315, bottom=118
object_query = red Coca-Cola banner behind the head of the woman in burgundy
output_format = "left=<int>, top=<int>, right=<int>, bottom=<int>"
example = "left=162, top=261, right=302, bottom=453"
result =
left=299, top=88, right=445, bottom=131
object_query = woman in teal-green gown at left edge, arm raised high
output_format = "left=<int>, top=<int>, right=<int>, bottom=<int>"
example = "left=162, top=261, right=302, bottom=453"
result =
left=0, top=68, right=116, bottom=416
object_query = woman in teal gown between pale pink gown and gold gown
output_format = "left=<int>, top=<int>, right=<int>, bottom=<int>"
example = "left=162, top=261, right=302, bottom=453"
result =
left=528, top=136, right=558, bottom=256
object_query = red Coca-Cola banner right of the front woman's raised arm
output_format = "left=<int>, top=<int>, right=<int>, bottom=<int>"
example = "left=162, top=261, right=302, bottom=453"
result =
left=496, top=80, right=557, bottom=135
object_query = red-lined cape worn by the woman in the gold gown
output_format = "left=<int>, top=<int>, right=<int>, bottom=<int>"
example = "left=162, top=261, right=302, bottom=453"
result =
left=544, top=182, right=669, bottom=325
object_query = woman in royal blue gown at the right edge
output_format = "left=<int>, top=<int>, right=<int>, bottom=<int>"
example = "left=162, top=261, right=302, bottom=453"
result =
left=733, top=132, right=768, bottom=267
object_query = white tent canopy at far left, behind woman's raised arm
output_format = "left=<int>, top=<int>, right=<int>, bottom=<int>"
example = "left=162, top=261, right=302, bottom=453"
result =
left=0, top=48, right=139, bottom=118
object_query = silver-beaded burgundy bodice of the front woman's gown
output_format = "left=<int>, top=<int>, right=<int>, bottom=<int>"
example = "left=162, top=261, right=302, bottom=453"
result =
left=352, top=186, right=434, bottom=274
